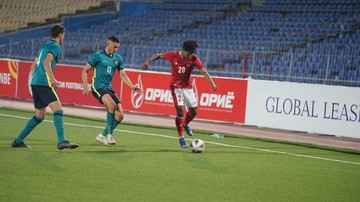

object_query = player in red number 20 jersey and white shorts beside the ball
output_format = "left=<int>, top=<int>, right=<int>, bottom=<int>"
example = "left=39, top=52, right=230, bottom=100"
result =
left=141, top=40, right=216, bottom=148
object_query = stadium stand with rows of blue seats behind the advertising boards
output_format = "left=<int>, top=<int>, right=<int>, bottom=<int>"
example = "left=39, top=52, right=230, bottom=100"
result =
left=0, top=0, right=360, bottom=86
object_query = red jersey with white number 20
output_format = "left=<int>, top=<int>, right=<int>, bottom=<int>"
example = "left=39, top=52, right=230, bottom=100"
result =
left=163, top=51, right=204, bottom=88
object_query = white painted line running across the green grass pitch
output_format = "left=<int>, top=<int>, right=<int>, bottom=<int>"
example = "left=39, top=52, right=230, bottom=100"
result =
left=0, top=114, right=360, bottom=165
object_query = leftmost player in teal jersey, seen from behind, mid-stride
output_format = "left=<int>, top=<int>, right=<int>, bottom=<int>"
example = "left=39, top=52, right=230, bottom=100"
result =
left=11, top=25, right=79, bottom=150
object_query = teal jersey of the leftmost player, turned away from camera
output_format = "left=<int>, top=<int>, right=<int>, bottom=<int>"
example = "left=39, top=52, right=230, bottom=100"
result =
left=30, top=40, right=61, bottom=87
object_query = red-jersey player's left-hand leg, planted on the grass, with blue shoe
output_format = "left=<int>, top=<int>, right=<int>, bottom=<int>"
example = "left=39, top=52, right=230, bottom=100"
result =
left=171, top=89, right=188, bottom=148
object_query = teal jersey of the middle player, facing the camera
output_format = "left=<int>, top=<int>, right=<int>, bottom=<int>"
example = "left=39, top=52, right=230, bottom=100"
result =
left=88, top=50, right=124, bottom=89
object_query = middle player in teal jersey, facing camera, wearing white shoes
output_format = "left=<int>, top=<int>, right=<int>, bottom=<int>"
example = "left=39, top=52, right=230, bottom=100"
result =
left=82, top=36, right=143, bottom=145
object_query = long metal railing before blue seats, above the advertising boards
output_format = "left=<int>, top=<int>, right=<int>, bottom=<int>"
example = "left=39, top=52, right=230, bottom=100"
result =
left=0, top=39, right=360, bottom=87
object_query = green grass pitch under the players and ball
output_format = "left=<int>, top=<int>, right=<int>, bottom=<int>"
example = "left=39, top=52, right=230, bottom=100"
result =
left=0, top=108, right=360, bottom=202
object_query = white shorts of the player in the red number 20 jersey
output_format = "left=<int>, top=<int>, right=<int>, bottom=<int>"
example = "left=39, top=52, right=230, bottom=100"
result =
left=171, top=88, right=197, bottom=108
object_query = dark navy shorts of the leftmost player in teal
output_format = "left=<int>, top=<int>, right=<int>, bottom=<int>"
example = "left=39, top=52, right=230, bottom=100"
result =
left=31, top=85, right=60, bottom=109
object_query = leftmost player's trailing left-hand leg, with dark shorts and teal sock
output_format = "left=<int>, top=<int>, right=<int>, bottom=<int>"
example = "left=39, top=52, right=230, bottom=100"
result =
left=11, top=86, right=46, bottom=148
